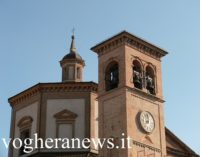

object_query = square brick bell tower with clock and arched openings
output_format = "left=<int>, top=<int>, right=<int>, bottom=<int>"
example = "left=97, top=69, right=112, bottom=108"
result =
left=91, top=31, right=167, bottom=157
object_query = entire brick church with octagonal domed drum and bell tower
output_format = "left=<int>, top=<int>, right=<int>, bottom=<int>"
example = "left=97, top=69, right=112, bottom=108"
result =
left=9, top=31, right=199, bottom=157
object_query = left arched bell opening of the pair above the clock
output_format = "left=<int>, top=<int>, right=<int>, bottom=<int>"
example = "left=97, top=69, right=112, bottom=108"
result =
left=133, top=60, right=142, bottom=89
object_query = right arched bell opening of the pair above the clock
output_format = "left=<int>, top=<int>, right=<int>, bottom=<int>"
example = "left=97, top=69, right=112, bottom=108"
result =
left=146, top=66, right=155, bottom=95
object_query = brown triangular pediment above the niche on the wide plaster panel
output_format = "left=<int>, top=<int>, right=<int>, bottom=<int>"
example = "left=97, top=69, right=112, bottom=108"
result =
left=54, top=109, right=77, bottom=120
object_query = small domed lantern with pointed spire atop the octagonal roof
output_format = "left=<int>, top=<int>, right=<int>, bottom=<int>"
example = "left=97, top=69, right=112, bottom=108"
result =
left=60, top=35, right=85, bottom=82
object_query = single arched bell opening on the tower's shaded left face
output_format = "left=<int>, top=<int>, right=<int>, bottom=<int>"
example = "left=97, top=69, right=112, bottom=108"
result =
left=105, top=61, right=119, bottom=91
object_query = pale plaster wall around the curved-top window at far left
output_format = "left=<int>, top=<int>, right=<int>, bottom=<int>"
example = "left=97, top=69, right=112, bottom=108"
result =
left=13, top=102, right=38, bottom=157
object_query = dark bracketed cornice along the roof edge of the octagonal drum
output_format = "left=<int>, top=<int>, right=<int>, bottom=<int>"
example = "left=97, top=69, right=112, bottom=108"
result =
left=8, top=82, right=98, bottom=106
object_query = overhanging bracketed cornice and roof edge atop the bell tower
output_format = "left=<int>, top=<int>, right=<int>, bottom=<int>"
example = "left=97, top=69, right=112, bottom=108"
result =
left=91, top=31, right=168, bottom=60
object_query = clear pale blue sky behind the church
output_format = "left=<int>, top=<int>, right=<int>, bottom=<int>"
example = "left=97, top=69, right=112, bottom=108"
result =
left=0, top=0, right=200, bottom=157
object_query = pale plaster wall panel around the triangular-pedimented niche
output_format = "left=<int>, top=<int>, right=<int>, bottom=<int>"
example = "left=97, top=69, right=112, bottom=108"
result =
left=46, top=99, right=85, bottom=139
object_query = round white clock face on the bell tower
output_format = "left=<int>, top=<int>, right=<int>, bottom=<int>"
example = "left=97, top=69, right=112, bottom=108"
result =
left=140, top=111, right=155, bottom=133
